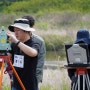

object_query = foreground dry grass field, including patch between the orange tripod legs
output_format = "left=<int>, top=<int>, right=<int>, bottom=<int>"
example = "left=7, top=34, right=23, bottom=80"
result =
left=2, top=68, right=70, bottom=90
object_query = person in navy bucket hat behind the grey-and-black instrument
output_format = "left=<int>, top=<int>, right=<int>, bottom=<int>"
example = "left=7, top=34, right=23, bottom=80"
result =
left=68, top=29, right=90, bottom=90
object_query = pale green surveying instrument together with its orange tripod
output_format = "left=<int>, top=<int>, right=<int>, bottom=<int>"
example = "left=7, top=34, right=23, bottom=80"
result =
left=0, top=26, right=26, bottom=90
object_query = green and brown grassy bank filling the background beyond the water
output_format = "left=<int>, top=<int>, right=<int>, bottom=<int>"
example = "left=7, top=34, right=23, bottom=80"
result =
left=0, top=0, right=90, bottom=60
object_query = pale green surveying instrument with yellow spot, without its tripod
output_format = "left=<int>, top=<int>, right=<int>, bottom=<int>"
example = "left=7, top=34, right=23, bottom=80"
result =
left=0, top=26, right=11, bottom=55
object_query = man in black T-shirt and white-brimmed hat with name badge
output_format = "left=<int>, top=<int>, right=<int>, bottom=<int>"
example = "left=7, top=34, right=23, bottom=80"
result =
left=7, top=18, right=40, bottom=90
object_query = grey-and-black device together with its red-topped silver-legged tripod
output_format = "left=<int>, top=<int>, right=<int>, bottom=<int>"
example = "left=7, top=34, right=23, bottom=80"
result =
left=65, top=44, right=90, bottom=90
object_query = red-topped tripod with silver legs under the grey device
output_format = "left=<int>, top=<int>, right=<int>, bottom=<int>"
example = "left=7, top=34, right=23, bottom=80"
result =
left=72, top=67, right=90, bottom=90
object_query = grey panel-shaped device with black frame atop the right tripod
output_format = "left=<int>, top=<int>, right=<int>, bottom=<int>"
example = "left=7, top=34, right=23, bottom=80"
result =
left=65, top=44, right=90, bottom=67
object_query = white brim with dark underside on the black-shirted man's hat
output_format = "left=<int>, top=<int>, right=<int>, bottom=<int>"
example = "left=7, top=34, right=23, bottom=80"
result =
left=8, top=23, right=35, bottom=32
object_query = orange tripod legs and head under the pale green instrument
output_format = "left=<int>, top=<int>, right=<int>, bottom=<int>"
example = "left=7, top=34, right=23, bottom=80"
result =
left=0, top=55, right=26, bottom=90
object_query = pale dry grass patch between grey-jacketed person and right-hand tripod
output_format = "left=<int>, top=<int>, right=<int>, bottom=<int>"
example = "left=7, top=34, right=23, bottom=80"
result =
left=42, top=69, right=70, bottom=90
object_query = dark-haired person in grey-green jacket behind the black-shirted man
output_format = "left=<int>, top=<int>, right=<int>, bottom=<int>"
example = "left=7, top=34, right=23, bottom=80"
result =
left=22, top=15, right=46, bottom=90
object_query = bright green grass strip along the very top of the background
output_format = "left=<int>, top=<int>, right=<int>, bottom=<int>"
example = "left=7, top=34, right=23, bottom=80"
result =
left=0, top=0, right=90, bottom=14
